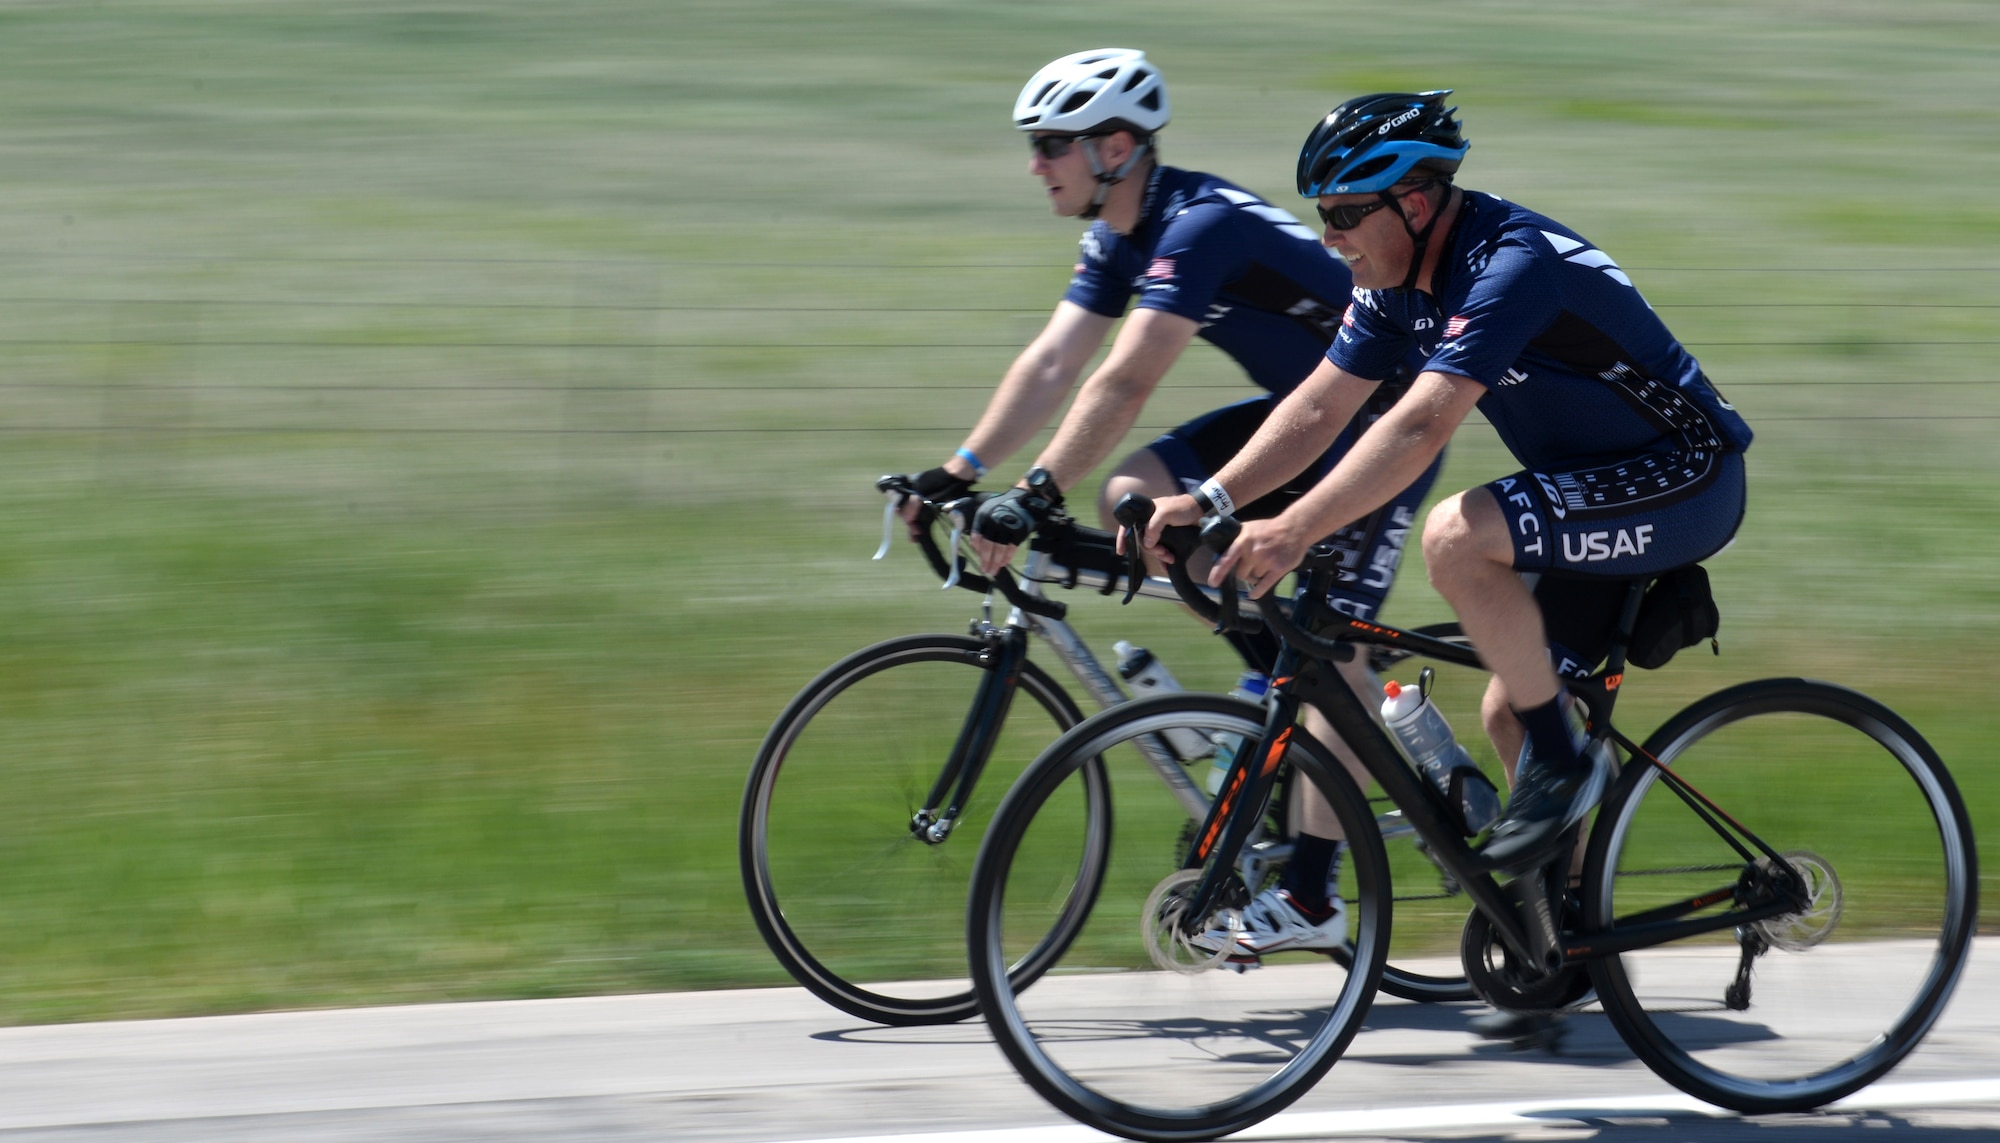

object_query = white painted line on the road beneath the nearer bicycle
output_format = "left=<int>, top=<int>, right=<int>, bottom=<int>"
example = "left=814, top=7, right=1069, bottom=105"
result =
left=768, top=1079, right=2000, bottom=1143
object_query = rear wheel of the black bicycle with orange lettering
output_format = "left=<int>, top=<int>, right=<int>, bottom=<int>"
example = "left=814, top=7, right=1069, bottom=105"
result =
left=1584, top=679, right=1978, bottom=1113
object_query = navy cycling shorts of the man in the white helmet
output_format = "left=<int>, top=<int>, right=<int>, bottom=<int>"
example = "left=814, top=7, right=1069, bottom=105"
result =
left=1146, top=394, right=1444, bottom=619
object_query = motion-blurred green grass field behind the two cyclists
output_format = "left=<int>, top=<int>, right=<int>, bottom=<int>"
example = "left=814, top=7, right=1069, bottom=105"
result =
left=0, top=0, right=2000, bottom=1023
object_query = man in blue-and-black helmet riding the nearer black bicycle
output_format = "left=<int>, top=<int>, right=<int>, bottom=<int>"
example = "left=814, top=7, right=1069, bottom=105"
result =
left=1148, top=90, right=1750, bottom=991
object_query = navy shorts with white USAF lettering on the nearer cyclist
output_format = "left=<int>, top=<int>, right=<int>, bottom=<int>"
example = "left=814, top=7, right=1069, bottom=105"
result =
left=1486, top=443, right=1744, bottom=577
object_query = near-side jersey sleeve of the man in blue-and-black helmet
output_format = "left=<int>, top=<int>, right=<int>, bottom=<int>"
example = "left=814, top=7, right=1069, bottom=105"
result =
left=1424, top=242, right=1562, bottom=390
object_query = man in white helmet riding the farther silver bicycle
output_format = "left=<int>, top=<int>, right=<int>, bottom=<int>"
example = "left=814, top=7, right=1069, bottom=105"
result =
left=906, top=48, right=1438, bottom=951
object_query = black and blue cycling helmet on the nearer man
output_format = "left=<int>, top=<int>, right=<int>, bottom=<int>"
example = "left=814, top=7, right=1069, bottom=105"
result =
left=1298, top=88, right=1472, bottom=198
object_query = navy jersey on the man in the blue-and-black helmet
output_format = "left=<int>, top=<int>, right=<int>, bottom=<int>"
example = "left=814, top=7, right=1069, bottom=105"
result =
left=1326, top=192, right=1752, bottom=470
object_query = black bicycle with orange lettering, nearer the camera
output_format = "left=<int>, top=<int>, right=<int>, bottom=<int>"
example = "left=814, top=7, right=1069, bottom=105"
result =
left=968, top=506, right=1978, bottom=1141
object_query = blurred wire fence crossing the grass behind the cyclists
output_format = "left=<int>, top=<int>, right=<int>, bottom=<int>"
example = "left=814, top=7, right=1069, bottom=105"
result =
left=0, top=252, right=2000, bottom=438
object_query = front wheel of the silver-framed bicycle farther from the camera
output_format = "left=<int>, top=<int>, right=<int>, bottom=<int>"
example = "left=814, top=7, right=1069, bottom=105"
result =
left=738, top=633, right=1108, bottom=1025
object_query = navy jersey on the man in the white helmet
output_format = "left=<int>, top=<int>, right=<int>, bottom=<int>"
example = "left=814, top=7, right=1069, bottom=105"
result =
left=1064, top=166, right=1360, bottom=396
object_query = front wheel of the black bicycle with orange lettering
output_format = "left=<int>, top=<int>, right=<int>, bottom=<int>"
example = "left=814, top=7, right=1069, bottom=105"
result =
left=966, top=693, right=1390, bottom=1143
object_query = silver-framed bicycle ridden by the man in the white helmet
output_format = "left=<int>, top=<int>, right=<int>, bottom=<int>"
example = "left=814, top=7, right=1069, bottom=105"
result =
left=738, top=478, right=1472, bottom=1025
